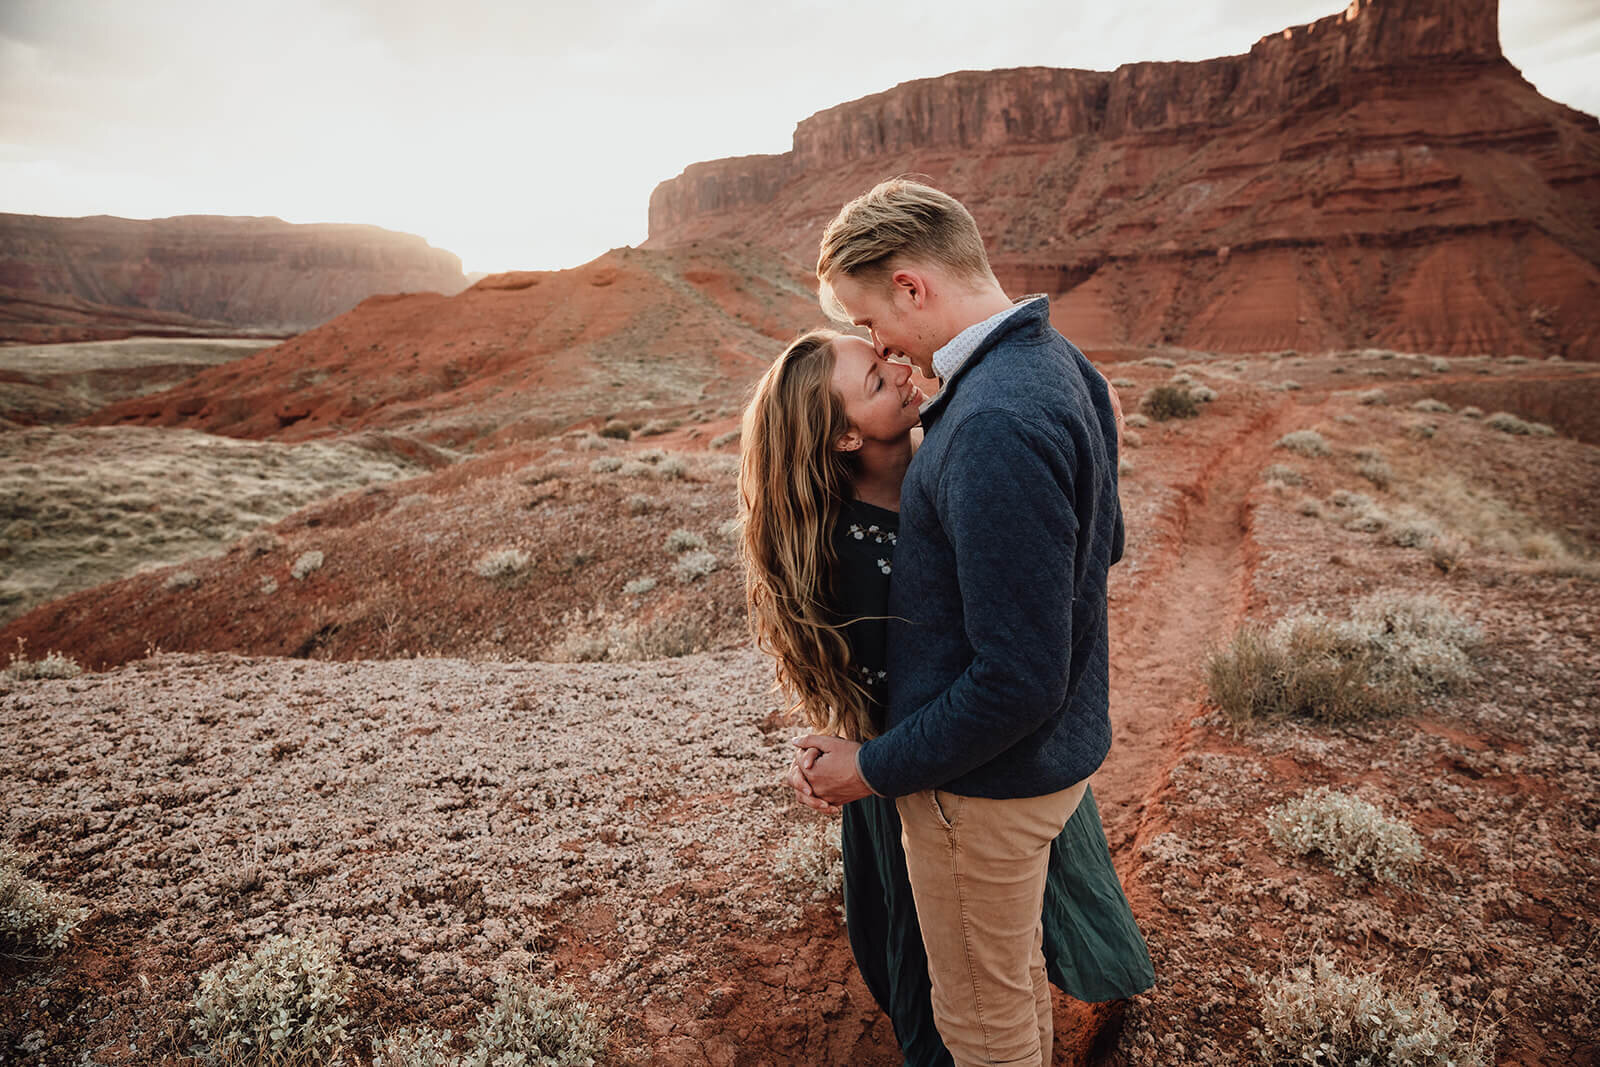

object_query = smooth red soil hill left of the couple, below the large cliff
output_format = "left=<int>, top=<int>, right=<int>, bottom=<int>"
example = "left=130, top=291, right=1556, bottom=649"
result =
left=90, top=243, right=821, bottom=445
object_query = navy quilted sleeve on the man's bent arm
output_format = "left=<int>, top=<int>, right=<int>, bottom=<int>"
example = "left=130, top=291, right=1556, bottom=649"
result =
left=859, top=411, right=1078, bottom=797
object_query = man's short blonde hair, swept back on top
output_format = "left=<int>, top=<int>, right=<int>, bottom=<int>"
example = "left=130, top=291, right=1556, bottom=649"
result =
left=816, top=178, right=994, bottom=320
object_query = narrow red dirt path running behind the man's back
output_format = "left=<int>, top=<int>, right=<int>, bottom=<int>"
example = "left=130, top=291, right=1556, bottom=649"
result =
left=1094, top=402, right=1294, bottom=872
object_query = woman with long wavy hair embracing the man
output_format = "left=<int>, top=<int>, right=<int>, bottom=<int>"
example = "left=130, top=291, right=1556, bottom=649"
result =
left=739, top=330, right=1154, bottom=1067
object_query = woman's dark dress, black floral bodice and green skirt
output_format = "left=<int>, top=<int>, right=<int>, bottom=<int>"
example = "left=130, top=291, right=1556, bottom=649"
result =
left=832, top=501, right=1155, bottom=1067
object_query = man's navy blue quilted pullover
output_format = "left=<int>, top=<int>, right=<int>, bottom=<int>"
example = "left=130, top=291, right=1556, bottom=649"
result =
left=861, top=301, right=1123, bottom=798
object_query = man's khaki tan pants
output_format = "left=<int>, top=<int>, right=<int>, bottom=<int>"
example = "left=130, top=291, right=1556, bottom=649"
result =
left=896, top=779, right=1088, bottom=1067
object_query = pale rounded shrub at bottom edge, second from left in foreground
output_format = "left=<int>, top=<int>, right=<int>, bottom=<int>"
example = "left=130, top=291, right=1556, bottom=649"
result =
left=189, top=934, right=352, bottom=1067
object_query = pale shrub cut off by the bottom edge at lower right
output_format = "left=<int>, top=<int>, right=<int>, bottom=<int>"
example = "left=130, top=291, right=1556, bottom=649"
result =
left=1250, top=955, right=1494, bottom=1067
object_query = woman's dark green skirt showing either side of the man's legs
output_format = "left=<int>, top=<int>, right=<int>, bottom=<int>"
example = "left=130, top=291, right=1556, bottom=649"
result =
left=840, top=790, right=1155, bottom=1067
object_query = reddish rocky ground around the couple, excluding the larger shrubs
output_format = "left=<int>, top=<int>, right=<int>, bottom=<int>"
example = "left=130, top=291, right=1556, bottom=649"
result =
left=0, top=354, right=1600, bottom=1064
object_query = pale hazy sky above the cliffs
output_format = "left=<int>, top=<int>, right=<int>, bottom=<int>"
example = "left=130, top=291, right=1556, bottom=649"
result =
left=0, top=0, right=1600, bottom=270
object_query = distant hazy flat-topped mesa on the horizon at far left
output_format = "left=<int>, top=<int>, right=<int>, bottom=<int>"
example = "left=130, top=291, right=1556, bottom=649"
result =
left=0, top=214, right=467, bottom=333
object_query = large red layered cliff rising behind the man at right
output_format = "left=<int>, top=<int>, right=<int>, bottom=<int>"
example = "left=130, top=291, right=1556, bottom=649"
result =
left=646, top=0, right=1600, bottom=358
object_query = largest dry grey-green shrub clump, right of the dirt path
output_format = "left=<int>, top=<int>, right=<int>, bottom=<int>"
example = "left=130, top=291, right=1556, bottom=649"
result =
left=1206, top=592, right=1482, bottom=723
